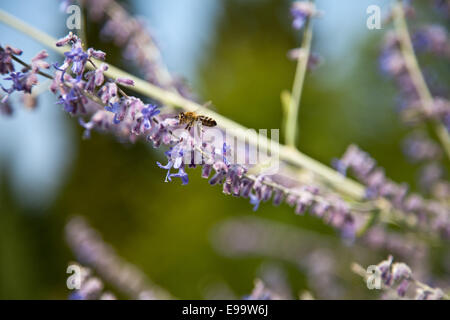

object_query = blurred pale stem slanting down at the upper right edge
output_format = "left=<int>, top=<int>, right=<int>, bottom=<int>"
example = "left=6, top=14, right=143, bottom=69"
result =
left=393, top=0, right=450, bottom=159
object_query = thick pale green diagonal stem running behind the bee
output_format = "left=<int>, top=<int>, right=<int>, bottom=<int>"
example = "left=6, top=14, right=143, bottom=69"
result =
left=0, top=9, right=364, bottom=200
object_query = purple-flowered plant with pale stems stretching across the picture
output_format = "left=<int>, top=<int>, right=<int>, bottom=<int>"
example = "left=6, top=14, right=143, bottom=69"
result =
left=0, top=0, right=450, bottom=299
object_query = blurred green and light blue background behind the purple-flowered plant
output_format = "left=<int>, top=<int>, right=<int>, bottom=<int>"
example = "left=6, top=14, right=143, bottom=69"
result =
left=0, top=0, right=448, bottom=299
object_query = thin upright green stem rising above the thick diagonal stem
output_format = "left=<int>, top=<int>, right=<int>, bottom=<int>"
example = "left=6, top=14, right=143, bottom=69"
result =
left=286, top=14, right=312, bottom=147
